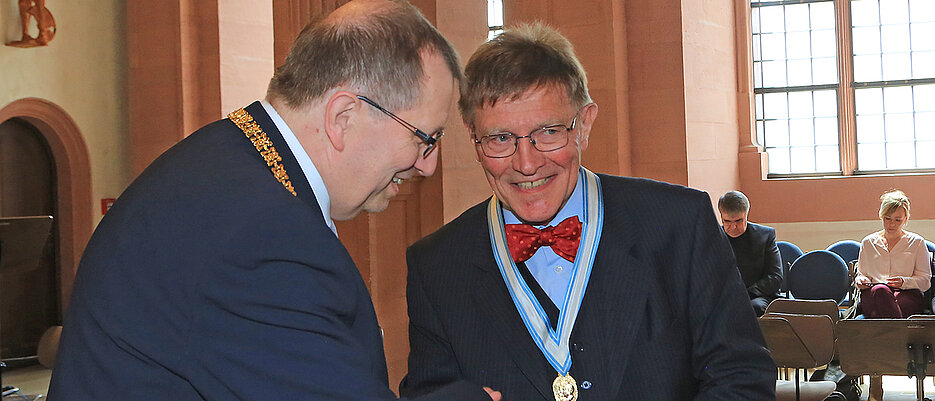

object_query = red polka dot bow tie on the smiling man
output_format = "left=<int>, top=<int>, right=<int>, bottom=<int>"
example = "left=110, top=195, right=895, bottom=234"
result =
left=506, top=216, right=581, bottom=263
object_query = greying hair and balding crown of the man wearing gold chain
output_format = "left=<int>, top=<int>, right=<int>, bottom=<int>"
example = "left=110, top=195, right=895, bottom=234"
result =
left=267, top=0, right=461, bottom=110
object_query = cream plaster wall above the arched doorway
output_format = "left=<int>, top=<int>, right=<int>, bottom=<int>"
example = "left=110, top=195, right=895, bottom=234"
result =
left=0, top=0, right=131, bottom=224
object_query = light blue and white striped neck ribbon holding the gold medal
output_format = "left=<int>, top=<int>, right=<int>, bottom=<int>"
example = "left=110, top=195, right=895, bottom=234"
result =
left=487, top=167, right=604, bottom=376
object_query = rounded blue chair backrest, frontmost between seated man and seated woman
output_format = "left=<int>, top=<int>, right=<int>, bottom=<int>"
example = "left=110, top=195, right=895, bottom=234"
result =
left=789, top=250, right=850, bottom=304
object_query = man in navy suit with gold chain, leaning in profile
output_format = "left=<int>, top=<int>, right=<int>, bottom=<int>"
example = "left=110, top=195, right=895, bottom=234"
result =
left=49, top=0, right=499, bottom=401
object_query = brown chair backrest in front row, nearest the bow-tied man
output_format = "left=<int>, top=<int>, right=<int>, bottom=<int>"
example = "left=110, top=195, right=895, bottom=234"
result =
left=757, top=314, right=834, bottom=368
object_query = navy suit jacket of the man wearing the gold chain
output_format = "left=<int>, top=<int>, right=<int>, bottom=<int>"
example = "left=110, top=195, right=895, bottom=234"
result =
left=49, top=102, right=489, bottom=401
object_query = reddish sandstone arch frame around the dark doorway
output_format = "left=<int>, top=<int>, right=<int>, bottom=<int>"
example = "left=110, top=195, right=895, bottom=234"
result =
left=0, top=98, right=94, bottom=358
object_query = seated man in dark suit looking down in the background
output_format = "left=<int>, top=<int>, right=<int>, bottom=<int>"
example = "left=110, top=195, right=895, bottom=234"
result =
left=717, top=191, right=782, bottom=316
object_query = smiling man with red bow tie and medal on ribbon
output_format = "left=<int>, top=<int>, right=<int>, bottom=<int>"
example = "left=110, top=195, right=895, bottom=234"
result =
left=400, top=25, right=776, bottom=401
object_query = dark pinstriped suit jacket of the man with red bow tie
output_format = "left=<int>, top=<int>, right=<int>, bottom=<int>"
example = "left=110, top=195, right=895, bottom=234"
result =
left=401, top=175, right=776, bottom=401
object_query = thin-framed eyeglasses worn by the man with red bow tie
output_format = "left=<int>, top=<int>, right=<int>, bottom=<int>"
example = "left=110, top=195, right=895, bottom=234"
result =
left=474, top=111, right=581, bottom=159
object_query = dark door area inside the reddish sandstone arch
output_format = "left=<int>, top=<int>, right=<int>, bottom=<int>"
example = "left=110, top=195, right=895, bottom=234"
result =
left=0, top=118, right=61, bottom=359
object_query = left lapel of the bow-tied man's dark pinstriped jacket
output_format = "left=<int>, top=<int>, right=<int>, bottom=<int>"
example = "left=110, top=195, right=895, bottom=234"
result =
left=472, top=208, right=556, bottom=400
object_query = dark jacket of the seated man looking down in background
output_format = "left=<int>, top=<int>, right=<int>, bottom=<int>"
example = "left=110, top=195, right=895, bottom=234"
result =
left=729, top=222, right=782, bottom=301
